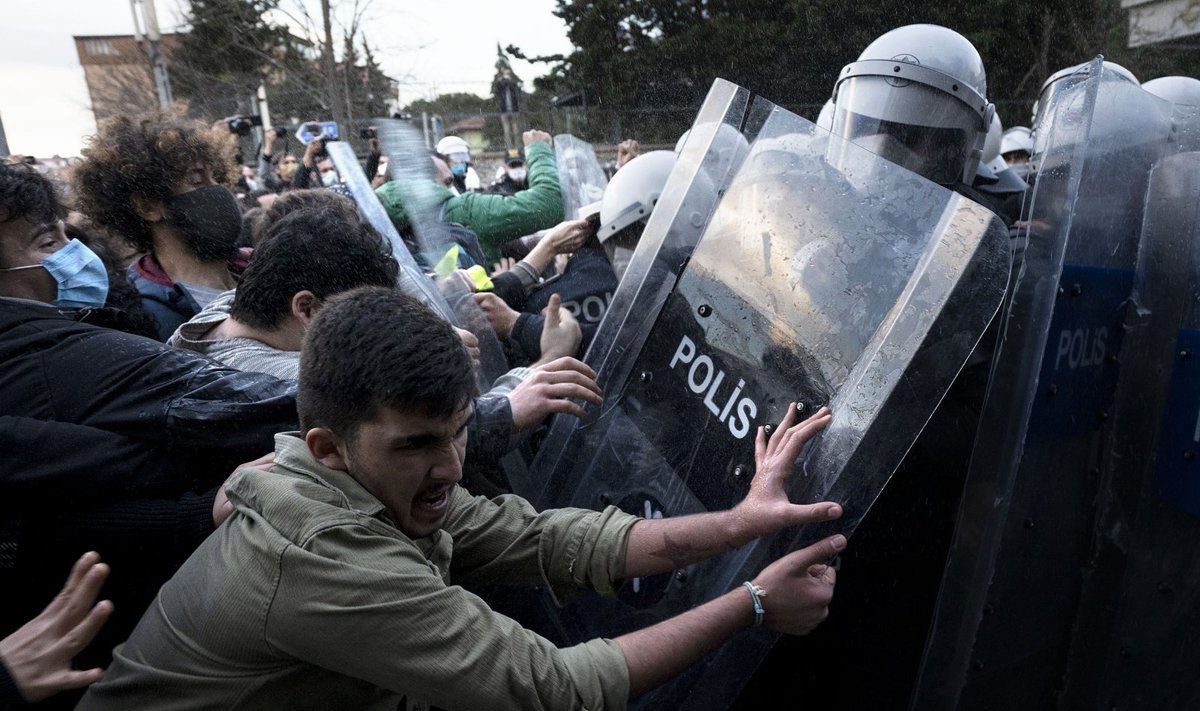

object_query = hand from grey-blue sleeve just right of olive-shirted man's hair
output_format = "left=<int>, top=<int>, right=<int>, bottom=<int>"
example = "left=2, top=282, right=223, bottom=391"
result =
left=508, top=358, right=604, bottom=432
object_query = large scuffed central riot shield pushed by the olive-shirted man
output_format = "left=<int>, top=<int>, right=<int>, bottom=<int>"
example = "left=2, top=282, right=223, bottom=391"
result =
left=530, top=79, right=1009, bottom=709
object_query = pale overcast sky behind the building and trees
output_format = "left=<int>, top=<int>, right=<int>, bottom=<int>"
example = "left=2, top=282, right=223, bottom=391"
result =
left=0, top=0, right=570, bottom=157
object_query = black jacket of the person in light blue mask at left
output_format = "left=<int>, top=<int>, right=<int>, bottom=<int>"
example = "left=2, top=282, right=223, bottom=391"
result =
left=0, top=298, right=298, bottom=691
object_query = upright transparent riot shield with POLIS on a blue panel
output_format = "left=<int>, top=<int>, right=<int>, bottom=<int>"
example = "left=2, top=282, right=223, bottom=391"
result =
left=913, top=58, right=1171, bottom=709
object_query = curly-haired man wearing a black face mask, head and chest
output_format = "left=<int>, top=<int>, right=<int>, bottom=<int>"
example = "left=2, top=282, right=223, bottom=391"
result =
left=73, top=112, right=248, bottom=340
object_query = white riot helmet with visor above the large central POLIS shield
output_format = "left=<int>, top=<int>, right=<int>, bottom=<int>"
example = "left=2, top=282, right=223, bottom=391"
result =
left=833, top=25, right=996, bottom=185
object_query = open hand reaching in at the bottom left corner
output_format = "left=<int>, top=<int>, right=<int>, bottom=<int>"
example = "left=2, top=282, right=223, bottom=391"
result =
left=0, top=552, right=113, bottom=704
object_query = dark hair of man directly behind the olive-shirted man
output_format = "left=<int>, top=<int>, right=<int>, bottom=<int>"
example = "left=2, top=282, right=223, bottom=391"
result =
left=229, top=208, right=400, bottom=329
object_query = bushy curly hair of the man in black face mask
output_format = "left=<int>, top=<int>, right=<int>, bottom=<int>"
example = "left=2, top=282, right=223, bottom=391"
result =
left=72, top=110, right=233, bottom=252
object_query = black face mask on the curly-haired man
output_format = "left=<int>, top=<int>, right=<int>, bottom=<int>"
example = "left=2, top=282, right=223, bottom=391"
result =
left=167, top=185, right=241, bottom=262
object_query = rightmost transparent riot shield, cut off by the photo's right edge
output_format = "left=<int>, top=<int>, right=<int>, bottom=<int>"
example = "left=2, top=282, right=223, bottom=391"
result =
left=1063, top=153, right=1200, bottom=709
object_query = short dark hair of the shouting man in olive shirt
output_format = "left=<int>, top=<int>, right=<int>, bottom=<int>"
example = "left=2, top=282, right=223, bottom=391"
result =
left=296, top=287, right=475, bottom=442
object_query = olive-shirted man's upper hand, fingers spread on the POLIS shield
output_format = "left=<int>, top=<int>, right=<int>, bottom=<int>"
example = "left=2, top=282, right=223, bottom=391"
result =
left=733, top=404, right=841, bottom=538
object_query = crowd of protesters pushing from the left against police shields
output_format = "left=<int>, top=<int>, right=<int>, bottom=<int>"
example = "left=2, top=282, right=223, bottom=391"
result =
left=0, top=18, right=1195, bottom=709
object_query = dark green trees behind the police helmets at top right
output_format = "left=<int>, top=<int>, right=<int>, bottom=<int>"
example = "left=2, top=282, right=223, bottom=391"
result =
left=508, top=0, right=1200, bottom=138
